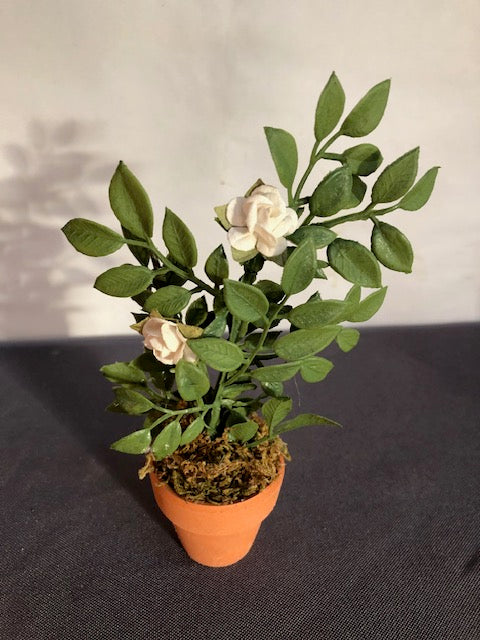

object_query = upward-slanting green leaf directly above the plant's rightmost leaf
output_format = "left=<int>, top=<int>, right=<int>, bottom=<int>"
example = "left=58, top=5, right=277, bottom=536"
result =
left=372, top=147, right=420, bottom=204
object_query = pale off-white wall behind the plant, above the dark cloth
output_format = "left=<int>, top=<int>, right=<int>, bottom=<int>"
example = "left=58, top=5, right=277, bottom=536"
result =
left=0, top=0, right=480, bottom=339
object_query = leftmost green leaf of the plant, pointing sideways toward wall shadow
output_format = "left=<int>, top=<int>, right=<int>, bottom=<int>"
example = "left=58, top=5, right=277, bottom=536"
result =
left=62, top=218, right=125, bottom=257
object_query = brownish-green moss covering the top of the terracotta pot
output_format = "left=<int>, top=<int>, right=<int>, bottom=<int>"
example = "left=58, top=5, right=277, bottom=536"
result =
left=148, top=416, right=290, bottom=504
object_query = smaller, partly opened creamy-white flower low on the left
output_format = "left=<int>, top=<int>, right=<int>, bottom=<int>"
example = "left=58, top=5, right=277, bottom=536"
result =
left=142, top=318, right=196, bottom=364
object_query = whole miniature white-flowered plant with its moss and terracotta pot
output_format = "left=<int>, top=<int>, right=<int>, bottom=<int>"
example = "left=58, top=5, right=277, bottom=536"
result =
left=63, top=73, right=438, bottom=566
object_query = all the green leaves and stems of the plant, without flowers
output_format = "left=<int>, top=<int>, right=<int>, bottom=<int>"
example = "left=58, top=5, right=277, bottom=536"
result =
left=63, top=73, right=438, bottom=461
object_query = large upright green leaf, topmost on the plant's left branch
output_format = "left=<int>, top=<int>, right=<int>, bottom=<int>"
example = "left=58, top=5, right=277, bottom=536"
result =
left=109, top=162, right=153, bottom=238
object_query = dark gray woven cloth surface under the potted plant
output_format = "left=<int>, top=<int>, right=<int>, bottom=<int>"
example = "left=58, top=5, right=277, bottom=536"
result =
left=0, top=325, right=480, bottom=640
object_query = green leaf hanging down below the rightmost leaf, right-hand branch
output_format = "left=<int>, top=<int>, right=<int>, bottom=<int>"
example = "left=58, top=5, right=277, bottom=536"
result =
left=372, top=222, right=413, bottom=273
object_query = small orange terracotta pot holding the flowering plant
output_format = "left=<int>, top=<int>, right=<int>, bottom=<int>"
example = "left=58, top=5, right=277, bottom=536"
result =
left=150, top=465, right=285, bottom=567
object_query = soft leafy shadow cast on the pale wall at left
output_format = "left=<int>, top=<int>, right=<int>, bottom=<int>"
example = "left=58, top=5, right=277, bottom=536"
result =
left=0, top=120, right=112, bottom=339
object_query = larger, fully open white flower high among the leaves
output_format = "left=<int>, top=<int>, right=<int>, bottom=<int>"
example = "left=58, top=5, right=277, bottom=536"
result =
left=227, top=184, right=298, bottom=258
